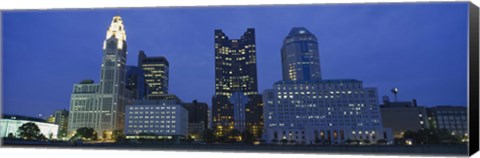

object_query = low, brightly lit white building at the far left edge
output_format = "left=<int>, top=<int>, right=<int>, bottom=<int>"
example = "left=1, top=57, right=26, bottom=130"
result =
left=0, top=115, right=58, bottom=139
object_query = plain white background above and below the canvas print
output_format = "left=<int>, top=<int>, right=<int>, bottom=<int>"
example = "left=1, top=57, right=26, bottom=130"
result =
left=0, top=0, right=480, bottom=158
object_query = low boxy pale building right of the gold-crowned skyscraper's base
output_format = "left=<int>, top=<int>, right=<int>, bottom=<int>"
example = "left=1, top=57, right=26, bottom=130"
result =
left=125, top=97, right=188, bottom=140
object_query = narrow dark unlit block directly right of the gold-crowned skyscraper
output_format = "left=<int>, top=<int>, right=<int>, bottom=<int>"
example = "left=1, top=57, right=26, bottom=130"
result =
left=126, top=66, right=147, bottom=100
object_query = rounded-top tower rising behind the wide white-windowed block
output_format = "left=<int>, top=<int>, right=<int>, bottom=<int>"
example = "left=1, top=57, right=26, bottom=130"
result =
left=282, top=27, right=321, bottom=81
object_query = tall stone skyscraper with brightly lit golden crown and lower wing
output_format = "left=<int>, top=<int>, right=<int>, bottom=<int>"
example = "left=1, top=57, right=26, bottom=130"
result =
left=69, top=16, right=130, bottom=139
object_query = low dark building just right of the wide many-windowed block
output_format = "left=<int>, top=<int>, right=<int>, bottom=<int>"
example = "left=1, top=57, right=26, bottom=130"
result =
left=380, top=99, right=429, bottom=138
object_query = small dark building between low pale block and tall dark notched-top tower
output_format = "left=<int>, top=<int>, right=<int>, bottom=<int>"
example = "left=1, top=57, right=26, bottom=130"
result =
left=183, top=100, right=208, bottom=140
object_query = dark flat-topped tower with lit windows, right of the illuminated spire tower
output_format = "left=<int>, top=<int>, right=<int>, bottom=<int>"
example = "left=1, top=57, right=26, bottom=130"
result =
left=138, top=50, right=169, bottom=95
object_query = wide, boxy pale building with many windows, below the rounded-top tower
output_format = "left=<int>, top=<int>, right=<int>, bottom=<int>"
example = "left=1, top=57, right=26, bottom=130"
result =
left=263, top=80, right=393, bottom=144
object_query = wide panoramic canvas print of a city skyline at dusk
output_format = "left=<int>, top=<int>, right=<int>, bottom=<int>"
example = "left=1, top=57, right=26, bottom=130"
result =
left=0, top=2, right=478, bottom=155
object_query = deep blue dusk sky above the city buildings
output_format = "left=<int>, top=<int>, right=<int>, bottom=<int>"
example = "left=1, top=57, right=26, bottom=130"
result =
left=2, top=2, right=468, bottom=116
